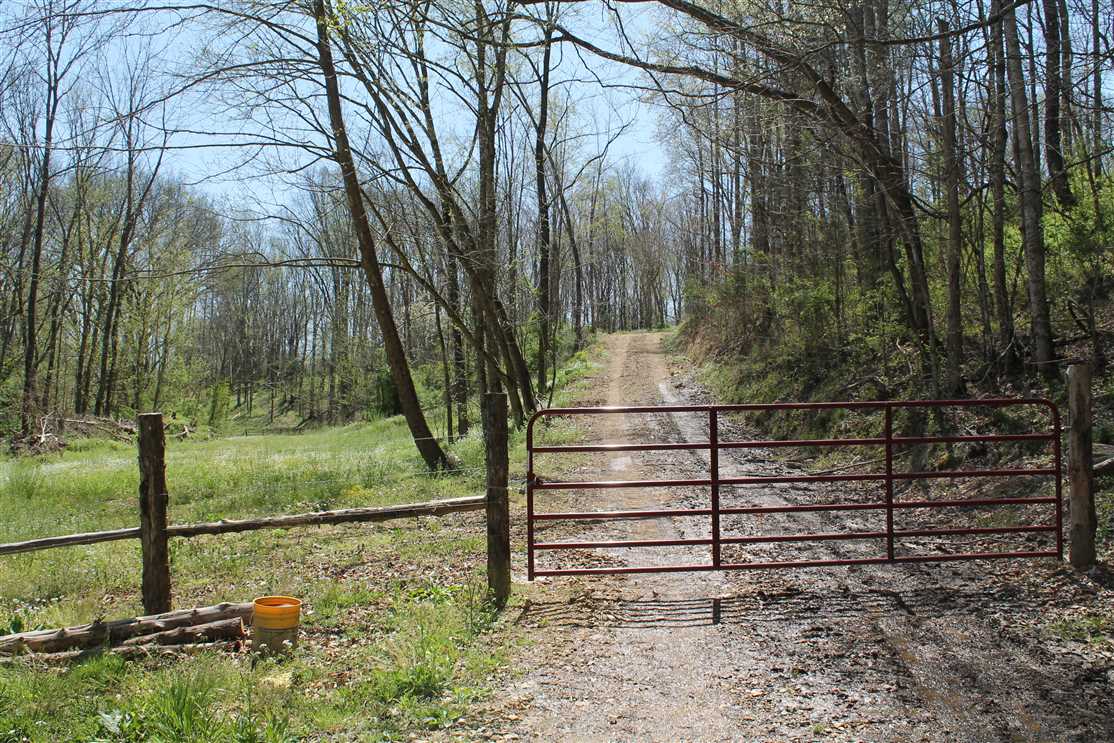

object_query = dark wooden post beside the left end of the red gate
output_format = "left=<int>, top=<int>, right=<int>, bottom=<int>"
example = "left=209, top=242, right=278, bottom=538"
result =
left=483, top=392, right=510, bottom=608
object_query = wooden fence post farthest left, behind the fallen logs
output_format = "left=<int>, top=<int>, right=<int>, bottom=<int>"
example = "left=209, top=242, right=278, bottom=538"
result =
left=139, top=413, right=170, bottom=614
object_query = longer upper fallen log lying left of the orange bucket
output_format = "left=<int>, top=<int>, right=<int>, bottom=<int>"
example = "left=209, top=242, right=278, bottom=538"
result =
left=0, top=603, right=252, bottom=655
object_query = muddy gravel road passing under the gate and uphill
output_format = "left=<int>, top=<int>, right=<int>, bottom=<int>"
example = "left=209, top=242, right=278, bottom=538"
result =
left=479, top=334, right=1114, bottom=742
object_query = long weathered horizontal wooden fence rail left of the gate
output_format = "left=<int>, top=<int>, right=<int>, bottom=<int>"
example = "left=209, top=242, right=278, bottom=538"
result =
left=0, top=496, right=486, bottom=555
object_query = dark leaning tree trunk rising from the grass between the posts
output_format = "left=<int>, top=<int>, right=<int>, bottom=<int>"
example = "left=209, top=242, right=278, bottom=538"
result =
left=313, top=0, right=449, bottom=470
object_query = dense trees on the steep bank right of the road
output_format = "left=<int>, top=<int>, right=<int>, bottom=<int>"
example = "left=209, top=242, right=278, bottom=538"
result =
left=529, top=0, right=1114, bottom=397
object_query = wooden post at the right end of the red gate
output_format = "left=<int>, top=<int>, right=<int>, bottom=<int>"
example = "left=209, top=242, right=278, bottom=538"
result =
left=1067, top=363, right=1098, bottom=570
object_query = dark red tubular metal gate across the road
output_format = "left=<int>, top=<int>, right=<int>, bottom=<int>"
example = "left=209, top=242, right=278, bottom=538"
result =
left=526, top=399, right=1064, bottom=580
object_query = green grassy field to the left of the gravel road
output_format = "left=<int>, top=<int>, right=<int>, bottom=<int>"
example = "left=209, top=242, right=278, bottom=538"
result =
left=0, top=355, right=590, bottom=743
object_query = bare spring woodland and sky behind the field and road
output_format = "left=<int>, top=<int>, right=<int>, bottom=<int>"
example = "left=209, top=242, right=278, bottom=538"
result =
left=0, top=0, right=1114, bottom=468
